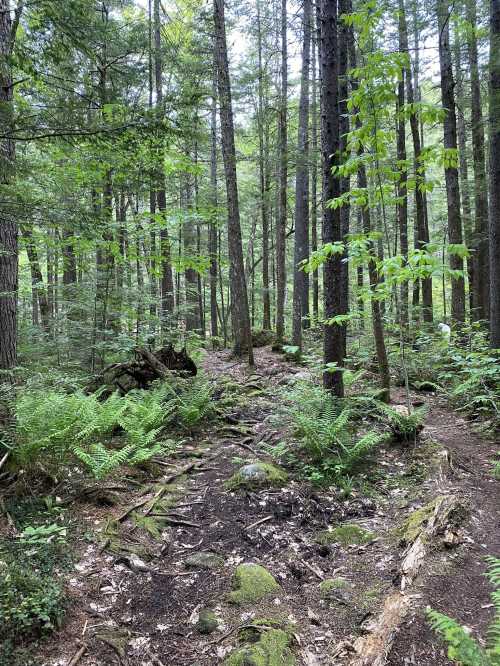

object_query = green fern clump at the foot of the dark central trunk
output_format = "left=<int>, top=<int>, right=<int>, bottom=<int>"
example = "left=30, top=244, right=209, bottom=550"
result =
left=291, top=384, right=389, bottom=482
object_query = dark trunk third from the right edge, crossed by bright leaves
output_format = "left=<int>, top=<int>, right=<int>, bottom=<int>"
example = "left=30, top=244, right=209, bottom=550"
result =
left=436, top=0, right=465, bottom=323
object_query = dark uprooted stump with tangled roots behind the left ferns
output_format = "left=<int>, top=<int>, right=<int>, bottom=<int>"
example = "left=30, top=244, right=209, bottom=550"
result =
left=87, top=345, right=197, bottom=396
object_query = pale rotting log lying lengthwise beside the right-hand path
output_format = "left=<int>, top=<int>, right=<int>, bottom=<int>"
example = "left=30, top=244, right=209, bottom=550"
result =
left=350, top=495, right=466, bottom=666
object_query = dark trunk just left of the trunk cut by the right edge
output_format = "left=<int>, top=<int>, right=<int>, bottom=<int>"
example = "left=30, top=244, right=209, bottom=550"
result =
left=466, top=0, right=490, bottom=319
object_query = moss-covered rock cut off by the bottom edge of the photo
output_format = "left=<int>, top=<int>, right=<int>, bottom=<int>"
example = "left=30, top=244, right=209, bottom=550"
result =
left=224, top=629, right=296, bottom=666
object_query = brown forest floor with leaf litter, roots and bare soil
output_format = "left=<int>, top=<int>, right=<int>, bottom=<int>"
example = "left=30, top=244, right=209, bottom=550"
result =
left=36, top=347, right=500, bottom=666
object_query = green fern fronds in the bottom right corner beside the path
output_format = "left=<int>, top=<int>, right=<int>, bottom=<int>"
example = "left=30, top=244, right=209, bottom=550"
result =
left=427, top=557, right=500, bottom=666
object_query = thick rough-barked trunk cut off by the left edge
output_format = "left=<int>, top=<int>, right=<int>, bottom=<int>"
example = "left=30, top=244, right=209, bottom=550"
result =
left=0, top=0, right=18, bottom=374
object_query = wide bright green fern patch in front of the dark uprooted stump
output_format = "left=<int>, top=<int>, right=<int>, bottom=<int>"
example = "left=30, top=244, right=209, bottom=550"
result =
left=12, top=379, right=213, bottom=479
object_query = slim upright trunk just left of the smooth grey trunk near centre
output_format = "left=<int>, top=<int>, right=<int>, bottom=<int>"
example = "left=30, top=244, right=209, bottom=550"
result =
left=276, top=0, right=288, bottom=344
